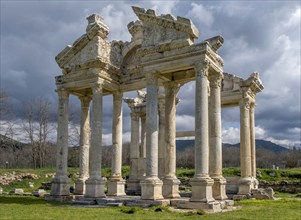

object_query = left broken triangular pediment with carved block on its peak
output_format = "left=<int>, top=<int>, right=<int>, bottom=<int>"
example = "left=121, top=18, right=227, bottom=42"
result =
left=55, top=14, right=123, bottom=74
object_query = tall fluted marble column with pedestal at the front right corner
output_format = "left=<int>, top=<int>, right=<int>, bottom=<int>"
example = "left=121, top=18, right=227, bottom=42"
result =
left=190, top=62, right=214, bottom=202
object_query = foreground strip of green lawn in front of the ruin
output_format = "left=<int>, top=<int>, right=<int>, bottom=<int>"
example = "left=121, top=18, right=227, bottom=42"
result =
left=0, top=195, right=301, bottom=220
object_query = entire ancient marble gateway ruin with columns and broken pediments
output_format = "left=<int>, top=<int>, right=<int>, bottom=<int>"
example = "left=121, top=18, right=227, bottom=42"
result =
left=50, top=7, right=263, bottom=206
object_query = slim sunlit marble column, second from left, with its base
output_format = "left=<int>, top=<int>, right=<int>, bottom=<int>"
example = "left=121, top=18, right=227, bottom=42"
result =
left=75, top=96, right=91, bottom=195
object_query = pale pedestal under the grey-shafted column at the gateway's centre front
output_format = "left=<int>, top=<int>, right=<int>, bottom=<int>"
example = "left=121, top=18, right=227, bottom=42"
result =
left=140, top=177, right=163, bottom=200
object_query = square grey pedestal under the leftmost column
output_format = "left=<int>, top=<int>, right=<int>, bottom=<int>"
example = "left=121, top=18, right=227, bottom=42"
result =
left=50, top=176, right=70, bottom=196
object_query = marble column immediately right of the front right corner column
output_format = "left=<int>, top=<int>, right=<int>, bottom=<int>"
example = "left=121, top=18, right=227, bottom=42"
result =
left=209, top=73, right=227, bottom=200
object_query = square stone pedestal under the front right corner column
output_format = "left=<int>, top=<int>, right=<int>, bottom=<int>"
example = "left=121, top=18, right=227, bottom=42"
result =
left=189, top=177, right=215, bottom=202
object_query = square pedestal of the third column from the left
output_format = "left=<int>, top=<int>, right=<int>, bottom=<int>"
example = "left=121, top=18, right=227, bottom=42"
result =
left=85, top=177, right=106, bottom=198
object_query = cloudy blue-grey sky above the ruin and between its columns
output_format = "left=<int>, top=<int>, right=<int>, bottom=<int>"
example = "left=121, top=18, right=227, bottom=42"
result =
left=0, top=0, right=301, bottom=146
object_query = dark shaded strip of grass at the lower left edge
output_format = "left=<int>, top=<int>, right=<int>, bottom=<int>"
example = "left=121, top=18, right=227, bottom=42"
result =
left=0, top=195, right=70, bottom=206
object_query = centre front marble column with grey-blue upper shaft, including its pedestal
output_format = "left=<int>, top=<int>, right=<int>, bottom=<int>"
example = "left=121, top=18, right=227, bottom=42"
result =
left=140, top=74, right=163, bottom=200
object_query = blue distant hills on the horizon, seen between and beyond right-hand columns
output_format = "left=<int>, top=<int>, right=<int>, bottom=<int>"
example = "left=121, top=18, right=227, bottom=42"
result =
left=176, top=140, right=289, bottom=153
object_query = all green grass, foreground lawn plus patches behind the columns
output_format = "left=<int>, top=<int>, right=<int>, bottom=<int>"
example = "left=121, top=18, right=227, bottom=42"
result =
left=0, top=166, right=301, bottom=220
